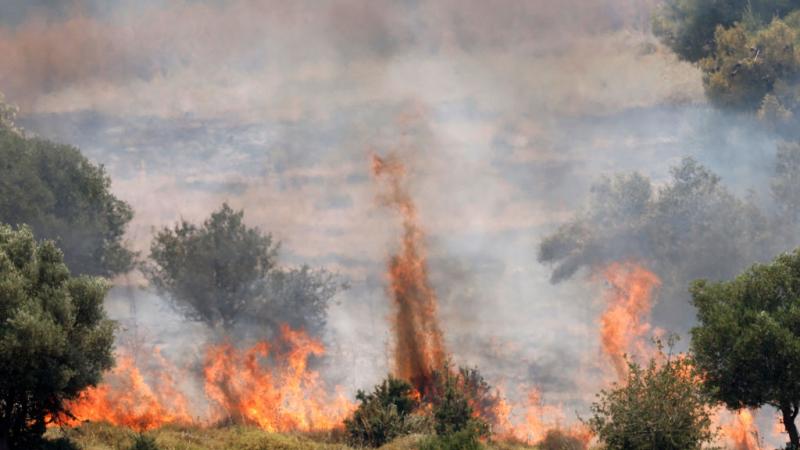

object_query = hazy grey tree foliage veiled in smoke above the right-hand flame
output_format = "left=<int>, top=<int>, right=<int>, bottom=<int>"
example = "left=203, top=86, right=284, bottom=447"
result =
left=538, top=158, right=769, bottom=290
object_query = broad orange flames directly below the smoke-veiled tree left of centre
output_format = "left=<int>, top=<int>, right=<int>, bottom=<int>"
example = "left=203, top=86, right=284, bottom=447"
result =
left=203, top=325, right=354, bottom=431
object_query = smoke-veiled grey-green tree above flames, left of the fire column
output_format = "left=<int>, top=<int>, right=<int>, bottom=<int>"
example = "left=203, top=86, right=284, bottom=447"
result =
left=145, top=204, right=342, bottom=335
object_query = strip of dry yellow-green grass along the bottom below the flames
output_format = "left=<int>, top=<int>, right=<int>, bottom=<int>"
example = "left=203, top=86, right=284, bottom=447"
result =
left=47, top=423, right=536, bottom=450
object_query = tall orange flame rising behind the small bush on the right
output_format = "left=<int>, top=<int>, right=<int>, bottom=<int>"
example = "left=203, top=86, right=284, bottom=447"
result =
left=600, top=263, right=661, bottom=380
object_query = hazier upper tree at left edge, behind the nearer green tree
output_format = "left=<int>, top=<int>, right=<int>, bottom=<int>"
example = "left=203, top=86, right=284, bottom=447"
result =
left=0, top=124, right=135, bottom=276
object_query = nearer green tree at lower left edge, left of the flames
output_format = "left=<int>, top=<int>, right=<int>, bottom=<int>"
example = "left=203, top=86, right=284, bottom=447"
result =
left=0, top=225, right=114, bottom=449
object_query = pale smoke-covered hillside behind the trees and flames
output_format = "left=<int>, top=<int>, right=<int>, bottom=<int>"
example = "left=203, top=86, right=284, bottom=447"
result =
left=0, top=0, right=788, bottom=428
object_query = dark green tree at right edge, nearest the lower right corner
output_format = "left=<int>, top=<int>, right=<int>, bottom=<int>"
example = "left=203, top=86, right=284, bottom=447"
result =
left=691, top=250, right=800, bottom=450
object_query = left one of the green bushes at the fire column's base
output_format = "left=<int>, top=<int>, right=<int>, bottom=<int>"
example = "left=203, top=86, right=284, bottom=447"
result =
left=344, top=375, right=425, bottom=447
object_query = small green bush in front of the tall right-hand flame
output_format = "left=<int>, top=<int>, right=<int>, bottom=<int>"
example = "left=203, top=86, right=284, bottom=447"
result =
left=586, top=343, right=714, bottom=450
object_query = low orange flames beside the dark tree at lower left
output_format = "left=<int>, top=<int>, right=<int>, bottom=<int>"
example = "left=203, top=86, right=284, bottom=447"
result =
left=60, top=350, right=192, bottom=431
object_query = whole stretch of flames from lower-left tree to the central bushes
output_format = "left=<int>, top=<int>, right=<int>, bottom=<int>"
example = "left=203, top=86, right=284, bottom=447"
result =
left=58, top=325, right=355, bottom=431
